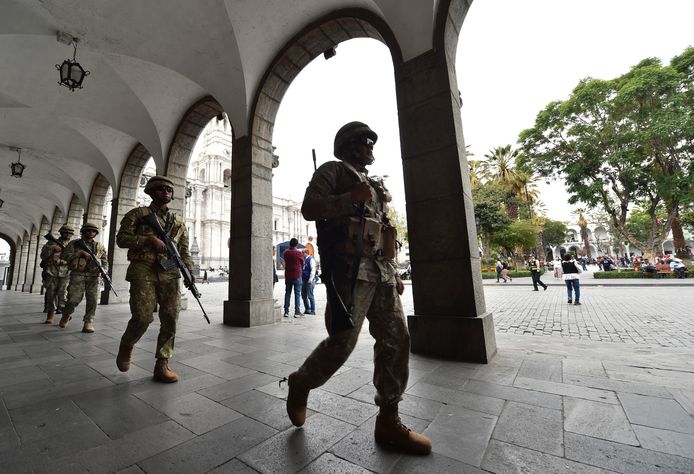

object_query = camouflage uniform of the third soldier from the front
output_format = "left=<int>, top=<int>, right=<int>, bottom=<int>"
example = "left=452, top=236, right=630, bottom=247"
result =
left=62, top=239, right=108, bottom=323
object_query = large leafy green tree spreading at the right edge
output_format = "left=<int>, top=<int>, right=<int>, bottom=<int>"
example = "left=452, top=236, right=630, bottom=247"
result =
left=520, top=48, right=694, bottom=255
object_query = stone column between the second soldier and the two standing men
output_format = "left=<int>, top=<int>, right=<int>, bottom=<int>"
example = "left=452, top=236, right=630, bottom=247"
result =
left=224, top=136, right=277, bottom=327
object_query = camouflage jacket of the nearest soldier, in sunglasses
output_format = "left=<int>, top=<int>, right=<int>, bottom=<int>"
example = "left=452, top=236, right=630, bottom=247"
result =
left=301, top=161, right=395, bottom=282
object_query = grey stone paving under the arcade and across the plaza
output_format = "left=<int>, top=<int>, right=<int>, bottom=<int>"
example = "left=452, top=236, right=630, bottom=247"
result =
left=0, top=276, right=694, bottom=473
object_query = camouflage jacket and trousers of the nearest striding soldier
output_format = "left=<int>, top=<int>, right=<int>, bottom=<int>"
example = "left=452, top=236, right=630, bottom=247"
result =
left=294, top=161, right=410, bottom=406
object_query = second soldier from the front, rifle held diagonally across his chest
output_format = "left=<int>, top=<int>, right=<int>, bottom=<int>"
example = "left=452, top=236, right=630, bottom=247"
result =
left=116, top=176, right=193, bottom=383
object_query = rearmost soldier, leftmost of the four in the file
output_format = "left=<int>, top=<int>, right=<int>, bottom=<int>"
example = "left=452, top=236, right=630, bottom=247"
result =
left=41, top=225, right=75, bottom=324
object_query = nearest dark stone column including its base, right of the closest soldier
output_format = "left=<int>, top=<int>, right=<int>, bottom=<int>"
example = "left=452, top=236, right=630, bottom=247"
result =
left=396, top=51, right=496, bottom=363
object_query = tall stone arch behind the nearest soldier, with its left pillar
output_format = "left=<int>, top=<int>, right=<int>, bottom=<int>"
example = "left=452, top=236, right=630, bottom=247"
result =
left=224, top=9, right=402, bottom=326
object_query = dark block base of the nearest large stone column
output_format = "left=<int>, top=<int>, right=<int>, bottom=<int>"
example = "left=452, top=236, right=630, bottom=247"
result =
left=407, top=313, right=496, bottom=364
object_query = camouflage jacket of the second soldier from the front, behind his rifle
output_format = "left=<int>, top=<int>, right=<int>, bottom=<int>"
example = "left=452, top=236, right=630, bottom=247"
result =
left=116, top=206, right=193, bottom=281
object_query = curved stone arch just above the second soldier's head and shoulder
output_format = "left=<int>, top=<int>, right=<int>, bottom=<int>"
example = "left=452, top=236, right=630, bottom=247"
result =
left=164, top=96, right=223, bottom=215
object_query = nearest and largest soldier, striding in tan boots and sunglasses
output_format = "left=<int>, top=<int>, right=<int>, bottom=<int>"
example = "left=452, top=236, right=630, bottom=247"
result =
left=287, top=122, right=431, bottom=454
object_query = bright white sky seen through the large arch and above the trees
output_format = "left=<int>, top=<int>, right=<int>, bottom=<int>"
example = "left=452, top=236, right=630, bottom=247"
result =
left=273, top=0, right=694, bottom=221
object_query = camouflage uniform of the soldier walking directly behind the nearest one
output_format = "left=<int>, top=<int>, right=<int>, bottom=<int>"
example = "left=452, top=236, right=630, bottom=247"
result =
left=116, top=206, right=193, bottom=359
